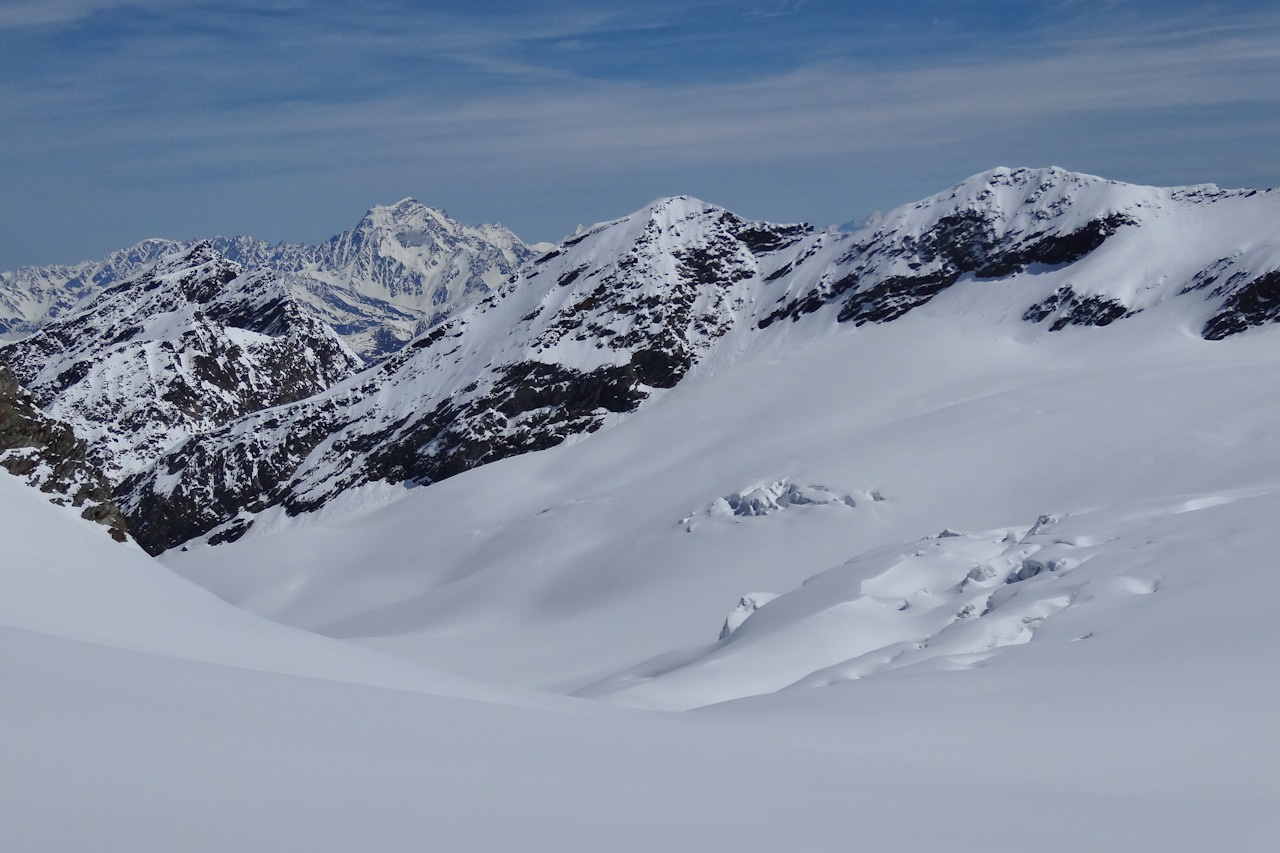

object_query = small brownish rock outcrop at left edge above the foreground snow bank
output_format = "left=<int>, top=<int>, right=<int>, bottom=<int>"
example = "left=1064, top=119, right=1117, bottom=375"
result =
left=0, top=362, right=127, bottom=542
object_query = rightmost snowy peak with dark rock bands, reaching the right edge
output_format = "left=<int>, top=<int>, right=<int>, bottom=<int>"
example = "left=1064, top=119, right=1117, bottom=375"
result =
left=760, top=168, right=1280, bottom=327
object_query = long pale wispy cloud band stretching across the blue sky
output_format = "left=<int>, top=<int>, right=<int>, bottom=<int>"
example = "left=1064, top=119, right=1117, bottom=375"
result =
left=30, top=13, right=1280, bottom=170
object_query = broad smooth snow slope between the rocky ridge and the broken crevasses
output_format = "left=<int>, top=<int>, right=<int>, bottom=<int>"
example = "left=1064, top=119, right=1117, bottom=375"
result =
left=165, top=312, right=1280, bottom=688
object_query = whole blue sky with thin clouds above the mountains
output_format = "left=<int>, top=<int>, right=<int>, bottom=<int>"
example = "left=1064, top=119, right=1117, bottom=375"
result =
left=0, top=0, right=1280, bottom=269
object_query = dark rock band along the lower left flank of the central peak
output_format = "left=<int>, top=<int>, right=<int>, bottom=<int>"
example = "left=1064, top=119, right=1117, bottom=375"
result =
left=116, top=353, right=654, bottom=553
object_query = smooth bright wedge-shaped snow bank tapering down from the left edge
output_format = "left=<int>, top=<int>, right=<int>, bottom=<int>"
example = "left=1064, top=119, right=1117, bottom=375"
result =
left=0, top=473, right=540, bottom=702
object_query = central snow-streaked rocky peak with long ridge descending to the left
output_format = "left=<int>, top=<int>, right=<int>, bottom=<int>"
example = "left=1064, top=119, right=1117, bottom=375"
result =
left=120, top=199, right=810, bottom=549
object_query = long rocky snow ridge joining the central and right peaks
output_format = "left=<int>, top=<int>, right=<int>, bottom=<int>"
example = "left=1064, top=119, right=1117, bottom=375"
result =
left=119, top=169, right=1280, bottom=549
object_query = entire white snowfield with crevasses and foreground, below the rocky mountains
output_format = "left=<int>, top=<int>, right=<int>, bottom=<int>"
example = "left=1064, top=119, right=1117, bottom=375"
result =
left=0, top=298, right=1280, bottom=852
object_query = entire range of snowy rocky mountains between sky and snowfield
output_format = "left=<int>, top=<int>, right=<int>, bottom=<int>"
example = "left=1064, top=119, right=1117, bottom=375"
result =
left=0, top=168, right=1280, bottom=552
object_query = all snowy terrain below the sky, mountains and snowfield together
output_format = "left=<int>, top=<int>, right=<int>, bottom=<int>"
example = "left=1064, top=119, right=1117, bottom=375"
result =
left=0, top=168, right=1280, bottom=852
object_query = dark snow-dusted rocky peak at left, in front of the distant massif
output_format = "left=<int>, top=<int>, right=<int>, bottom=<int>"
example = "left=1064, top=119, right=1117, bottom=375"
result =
left=0, top=242, right=364, bottom=480
